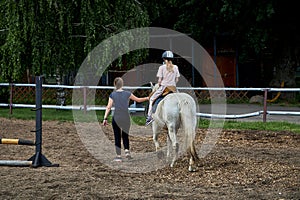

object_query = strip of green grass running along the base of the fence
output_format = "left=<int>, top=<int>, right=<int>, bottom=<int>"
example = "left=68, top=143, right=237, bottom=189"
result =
left=0, top=108, right=300, bottom=133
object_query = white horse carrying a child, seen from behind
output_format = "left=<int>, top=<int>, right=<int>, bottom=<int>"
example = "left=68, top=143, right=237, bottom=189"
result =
left=152, top=84, right=199, bottom=172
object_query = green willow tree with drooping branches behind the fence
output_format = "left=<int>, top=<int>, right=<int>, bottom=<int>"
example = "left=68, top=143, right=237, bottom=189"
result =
left=0, top=0, right=149, bottom=82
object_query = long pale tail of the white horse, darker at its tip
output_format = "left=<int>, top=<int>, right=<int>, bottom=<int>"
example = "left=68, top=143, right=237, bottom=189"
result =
left=180, top=96, right=199, bottom=161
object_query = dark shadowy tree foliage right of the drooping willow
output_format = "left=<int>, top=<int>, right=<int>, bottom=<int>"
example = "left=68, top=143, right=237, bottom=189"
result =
left=140, top=0, right=300, bottom=86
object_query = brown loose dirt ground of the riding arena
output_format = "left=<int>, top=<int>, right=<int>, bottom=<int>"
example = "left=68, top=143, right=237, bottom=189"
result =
left=0, top=118, right=300, bottom=199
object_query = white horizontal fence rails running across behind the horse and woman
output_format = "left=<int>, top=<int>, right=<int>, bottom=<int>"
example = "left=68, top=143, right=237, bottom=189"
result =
left=0, top=83, right=300, bottom=122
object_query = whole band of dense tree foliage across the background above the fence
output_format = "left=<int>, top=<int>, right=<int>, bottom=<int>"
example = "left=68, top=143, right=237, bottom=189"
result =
left=0, top=0, right=300, bottom=86
